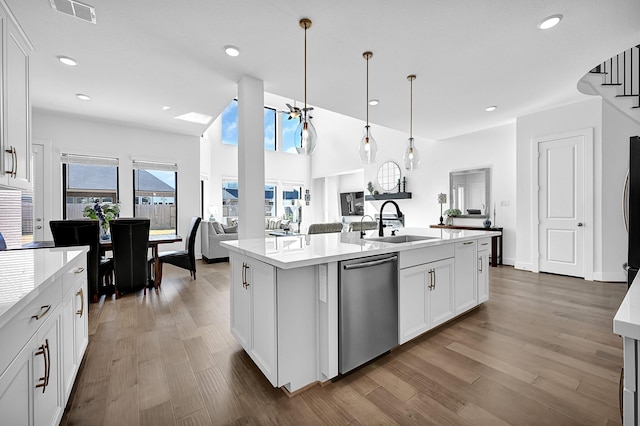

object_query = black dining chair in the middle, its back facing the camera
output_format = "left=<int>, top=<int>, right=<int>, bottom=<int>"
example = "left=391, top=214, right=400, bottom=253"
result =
left=109, top=218, right=150, bottom=299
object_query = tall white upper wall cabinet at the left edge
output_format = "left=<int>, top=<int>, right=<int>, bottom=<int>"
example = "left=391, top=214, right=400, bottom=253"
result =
left=0, top=3, right=31, bottom=189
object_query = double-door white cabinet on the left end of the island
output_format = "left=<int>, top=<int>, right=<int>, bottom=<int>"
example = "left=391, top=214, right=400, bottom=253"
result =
left=230, top=253, right=278, bottom=386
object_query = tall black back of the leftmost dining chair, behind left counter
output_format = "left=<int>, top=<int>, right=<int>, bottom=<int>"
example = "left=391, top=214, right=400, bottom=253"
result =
left=49, top=219, right=100, bottom=298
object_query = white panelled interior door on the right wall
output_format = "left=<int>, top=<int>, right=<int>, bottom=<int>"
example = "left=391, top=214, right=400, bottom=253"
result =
left=538, top=135, right=591, bottom=277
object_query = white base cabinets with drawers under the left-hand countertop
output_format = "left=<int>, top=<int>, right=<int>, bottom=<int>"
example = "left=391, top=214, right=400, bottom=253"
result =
left=0, top=252, right=88, bottom=426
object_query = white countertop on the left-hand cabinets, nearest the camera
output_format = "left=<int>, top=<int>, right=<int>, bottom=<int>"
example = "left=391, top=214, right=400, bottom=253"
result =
left=0, top=247, right=88, bottom=327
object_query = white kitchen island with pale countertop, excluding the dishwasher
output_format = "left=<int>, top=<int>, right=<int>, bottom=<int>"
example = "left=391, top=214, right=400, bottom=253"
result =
left=221, top=228, right=496, bottom=392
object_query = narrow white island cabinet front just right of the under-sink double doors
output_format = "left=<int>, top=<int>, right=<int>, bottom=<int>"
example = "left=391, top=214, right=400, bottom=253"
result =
left=454, top=240, right=478, bottom=315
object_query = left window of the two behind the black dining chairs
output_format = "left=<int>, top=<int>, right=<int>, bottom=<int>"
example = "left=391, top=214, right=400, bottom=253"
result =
left=61, top=154, right=118, bottom=219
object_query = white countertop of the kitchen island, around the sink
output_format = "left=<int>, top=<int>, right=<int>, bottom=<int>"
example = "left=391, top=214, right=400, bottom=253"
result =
left=220, top=228, right=500, bottom=269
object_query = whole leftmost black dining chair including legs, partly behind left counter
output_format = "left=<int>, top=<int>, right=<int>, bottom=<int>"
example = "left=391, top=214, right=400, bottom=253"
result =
left=49, top=219, right=113, bottom=302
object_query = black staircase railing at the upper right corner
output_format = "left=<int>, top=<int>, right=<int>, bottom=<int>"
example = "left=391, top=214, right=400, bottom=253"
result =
left=590, top=45, right=640, bottom=108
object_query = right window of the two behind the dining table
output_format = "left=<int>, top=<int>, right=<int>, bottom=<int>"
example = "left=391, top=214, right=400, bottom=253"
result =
left=133, top=160, right=178, bottom=235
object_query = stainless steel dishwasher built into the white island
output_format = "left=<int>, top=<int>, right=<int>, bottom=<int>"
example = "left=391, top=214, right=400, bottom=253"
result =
left=338, top=253, right=398, bottom=374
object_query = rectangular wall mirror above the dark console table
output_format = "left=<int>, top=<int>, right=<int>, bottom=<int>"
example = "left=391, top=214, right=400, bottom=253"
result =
left=449, top=168, right=491, bottom=218
